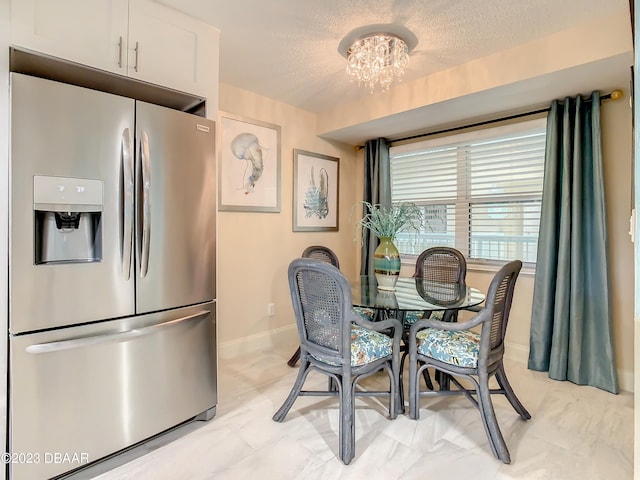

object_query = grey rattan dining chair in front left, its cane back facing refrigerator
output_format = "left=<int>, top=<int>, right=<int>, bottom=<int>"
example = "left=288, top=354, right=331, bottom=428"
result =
left=273, top=258, right=402, bottom=465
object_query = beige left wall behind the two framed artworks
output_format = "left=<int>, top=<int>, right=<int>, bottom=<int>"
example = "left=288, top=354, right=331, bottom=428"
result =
left=217, top=84, right=362, bottom=355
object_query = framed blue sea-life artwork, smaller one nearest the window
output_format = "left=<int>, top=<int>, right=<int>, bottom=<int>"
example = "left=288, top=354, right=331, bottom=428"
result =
left=293, top=149, right=340, bottom=232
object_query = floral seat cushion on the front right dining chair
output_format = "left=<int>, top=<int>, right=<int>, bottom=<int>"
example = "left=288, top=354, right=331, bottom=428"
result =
left=416, top=328, right=480, bottom=368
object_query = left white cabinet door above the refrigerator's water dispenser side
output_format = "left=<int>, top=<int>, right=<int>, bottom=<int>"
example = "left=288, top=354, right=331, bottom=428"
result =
left=11, top=0, right=128, bottom=74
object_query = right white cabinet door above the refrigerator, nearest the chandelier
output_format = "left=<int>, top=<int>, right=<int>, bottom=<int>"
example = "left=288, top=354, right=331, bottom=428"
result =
left=128, top=0, right=218, bottom=97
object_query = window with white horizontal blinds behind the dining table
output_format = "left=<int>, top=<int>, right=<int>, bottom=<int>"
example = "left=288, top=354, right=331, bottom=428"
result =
left=390, top=119, right=546, bottom=263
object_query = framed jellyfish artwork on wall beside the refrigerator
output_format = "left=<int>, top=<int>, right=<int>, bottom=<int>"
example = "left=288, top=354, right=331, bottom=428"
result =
left=218, top=112, right=280, bottom=212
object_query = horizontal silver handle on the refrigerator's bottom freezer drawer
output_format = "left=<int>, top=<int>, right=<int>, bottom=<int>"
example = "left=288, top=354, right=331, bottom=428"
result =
left=25, top=310, right=211, bottom=355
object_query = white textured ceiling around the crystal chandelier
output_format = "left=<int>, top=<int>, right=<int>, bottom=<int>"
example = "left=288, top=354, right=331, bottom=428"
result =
left=157, top=0, right=629, bottom=112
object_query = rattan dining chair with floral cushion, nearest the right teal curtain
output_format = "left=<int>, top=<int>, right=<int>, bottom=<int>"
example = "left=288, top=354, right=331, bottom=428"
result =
left=409, top=260, right=531, bottom=463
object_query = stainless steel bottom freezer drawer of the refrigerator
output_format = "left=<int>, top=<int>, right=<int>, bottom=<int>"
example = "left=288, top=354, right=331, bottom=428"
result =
left=9, top=302, right=217, bottom=480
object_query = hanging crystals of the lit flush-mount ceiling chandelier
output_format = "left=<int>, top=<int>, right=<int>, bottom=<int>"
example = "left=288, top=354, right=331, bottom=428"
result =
left=347, top=33, right=409, bottom=93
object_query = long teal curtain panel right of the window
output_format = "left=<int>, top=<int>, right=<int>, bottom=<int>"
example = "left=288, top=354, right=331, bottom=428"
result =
left=529, top=92, right=619, bottom=393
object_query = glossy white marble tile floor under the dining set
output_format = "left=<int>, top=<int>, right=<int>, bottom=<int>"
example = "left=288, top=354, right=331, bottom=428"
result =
left=86, top=345, right=633, bottom=480
